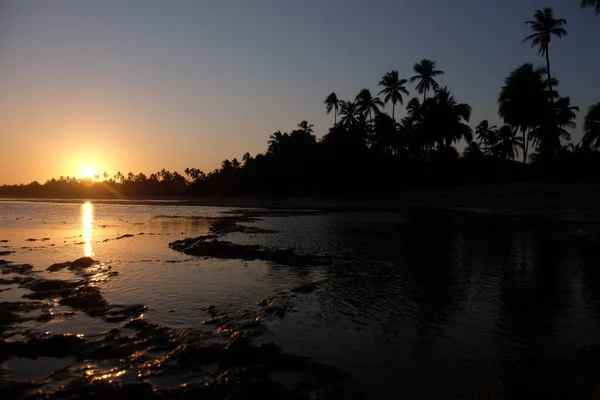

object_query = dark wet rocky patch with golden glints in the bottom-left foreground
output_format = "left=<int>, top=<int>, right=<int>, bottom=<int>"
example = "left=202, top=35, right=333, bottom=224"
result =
left=0, top=319, right=363, bottom=399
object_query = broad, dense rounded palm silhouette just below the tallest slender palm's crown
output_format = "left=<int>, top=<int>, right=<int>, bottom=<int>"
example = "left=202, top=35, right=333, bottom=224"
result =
left=498, top=64, right=548, bottom=162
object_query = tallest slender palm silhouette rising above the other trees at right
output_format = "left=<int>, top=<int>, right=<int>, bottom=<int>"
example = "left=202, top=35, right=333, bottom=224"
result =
left=523, top=7, right=567, bottom=97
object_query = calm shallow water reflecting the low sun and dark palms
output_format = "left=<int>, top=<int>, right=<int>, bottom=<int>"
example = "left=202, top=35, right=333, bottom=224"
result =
left=0, top=201, right=600, bottom=398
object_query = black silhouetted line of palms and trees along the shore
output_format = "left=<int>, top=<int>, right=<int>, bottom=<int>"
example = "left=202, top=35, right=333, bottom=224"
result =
left=0, top=0, right=600, bottom=197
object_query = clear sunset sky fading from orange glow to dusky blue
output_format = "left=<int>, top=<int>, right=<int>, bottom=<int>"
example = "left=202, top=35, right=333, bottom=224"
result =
left=0, top=0, right=600, bottom=184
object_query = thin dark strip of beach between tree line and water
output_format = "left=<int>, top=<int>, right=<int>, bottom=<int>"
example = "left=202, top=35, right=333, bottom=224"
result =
left=0, top=183, right=600, bottom=214
